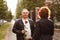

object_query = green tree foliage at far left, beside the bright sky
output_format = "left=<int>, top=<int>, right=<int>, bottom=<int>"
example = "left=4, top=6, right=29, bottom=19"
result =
left=0, top=0, right=12, bottom=21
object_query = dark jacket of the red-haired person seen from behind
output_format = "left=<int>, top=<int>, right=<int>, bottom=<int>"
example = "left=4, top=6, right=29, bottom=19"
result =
left=33, top=18, right=54, bottom=40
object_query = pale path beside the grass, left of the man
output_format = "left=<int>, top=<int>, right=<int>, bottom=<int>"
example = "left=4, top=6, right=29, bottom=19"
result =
left=5, top=20, right=16, bottom=40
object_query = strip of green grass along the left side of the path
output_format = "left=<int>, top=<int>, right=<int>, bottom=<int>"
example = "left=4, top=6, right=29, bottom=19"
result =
left=0, top=23, right=9, bottom=40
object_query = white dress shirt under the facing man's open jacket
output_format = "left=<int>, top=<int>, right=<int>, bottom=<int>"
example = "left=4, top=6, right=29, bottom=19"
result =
left=22, top=18, right=31, bottom=39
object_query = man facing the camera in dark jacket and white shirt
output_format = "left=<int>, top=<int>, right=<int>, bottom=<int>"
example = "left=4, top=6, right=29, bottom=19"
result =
left=13, top=9, right=34, bottom=40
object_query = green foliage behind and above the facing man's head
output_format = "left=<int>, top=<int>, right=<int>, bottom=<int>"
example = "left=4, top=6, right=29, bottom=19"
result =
left=16, top=0, right=45, bottom=18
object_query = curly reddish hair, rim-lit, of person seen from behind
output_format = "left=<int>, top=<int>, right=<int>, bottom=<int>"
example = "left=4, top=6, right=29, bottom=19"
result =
left=39, top=7, right=51, bottom=18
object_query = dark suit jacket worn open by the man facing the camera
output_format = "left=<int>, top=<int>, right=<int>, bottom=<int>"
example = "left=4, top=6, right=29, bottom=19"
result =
left=12, top=19, right=34, bottom=40
